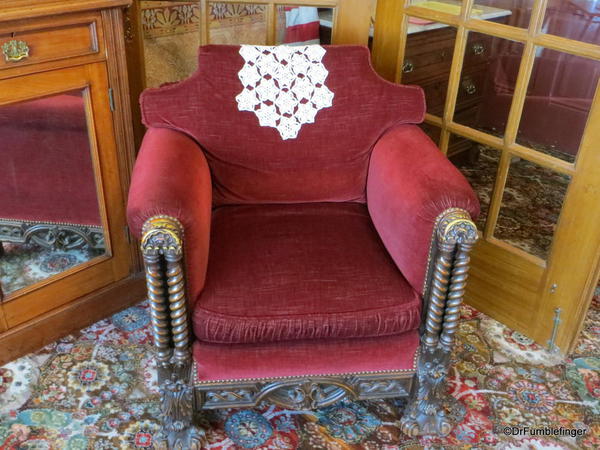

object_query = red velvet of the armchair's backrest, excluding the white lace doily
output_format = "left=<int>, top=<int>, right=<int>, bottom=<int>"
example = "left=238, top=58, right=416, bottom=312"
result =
left=141, top=45, right=425, bottom=205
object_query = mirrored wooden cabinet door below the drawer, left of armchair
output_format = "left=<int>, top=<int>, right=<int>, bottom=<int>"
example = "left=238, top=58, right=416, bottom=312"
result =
left=0, top=62, right=132, bottom=331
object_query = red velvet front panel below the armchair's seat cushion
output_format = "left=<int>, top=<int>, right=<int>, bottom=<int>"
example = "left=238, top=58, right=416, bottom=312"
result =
left=193, top=330, right=419, bottom=382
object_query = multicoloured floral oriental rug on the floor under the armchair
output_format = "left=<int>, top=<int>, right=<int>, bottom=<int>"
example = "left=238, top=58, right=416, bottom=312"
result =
left=0, top=289, right=600, bottom=450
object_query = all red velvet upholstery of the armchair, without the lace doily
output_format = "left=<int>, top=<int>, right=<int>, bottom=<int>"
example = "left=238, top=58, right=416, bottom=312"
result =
left=128, top=46, right=478, bottom=356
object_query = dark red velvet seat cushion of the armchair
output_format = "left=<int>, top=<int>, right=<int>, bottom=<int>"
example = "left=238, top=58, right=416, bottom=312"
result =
left=193, top=203, right=421, bottom=344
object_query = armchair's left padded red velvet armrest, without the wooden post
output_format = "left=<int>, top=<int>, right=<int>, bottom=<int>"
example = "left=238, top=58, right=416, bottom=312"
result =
left=127, top=128, right=212, bottom=304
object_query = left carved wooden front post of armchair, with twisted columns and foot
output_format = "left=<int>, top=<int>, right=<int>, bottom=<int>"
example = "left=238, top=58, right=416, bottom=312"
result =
left=142, top=216, right=205, bottom=450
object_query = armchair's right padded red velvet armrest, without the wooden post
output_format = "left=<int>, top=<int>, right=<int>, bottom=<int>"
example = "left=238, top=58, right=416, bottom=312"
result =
left=367, top=125, right=479, bottom=295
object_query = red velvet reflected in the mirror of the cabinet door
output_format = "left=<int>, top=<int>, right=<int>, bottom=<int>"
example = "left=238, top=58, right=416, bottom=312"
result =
left=0, top=94, right=101, bottom=226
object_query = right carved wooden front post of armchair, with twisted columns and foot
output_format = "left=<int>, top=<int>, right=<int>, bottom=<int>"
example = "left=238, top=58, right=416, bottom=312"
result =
left=401, top=209, right=477, bottom=437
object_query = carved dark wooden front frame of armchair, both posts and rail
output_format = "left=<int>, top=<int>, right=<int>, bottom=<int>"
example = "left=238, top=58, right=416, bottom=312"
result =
left=141, top=208, right=478, bottom=449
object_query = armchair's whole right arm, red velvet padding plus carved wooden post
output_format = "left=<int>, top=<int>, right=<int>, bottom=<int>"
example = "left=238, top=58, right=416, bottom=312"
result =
left=367, top=125, right=479, bottom=436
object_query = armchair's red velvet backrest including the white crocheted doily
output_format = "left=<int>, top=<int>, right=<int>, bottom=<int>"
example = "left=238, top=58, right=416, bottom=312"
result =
left=141, top=45, right=425, bottom=205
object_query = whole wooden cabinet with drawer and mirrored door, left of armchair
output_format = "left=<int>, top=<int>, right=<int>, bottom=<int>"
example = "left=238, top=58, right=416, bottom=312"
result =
left=0, top=0, right=144, bottom=363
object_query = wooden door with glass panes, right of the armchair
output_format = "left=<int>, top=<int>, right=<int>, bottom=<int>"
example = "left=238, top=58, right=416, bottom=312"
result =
left=373, top=0, right=600, bottom=351
